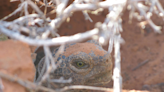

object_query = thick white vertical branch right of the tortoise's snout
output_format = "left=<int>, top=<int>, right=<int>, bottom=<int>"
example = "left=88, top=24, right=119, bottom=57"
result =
left=103, top=0, right=127, bottom=92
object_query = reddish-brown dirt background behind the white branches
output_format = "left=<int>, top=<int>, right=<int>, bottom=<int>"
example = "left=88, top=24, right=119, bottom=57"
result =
left=0, top=0, right=164, bottom=92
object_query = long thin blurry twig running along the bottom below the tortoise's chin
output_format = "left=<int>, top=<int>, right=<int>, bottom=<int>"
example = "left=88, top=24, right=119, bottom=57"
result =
left=0, top=72, right=112, bottom=92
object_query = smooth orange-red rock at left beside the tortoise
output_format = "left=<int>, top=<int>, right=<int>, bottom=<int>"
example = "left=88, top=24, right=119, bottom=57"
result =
left=0, top=40, right=35, bottom=92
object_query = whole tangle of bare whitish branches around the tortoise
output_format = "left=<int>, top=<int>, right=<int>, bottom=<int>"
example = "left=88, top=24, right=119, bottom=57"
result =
left=0, top=0, right=164, bottom=92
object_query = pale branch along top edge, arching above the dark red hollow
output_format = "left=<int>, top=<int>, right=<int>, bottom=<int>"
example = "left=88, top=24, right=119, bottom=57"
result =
left=50, top=0, right=127, bottom=29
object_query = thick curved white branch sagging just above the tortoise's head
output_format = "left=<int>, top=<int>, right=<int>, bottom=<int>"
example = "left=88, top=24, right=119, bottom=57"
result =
left=0, top=25, right=99, bottom=46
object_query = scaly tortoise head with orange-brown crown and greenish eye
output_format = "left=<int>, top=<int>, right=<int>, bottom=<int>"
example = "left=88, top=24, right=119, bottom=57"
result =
left=38, top=40, right=112, bottom=92
